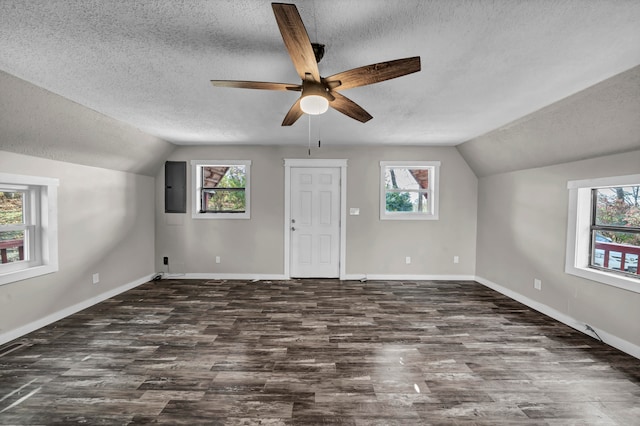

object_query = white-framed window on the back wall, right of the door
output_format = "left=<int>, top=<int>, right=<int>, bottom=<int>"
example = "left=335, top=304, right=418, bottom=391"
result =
left=380, top=161, right=440, bottom=220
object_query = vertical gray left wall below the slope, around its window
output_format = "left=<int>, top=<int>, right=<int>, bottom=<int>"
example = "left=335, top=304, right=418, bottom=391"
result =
left=0, top=151, right=154, bottom=343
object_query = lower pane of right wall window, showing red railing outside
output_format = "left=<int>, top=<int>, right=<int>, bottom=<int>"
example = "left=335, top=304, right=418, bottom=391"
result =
left=591, top=231, right=640, bottom=274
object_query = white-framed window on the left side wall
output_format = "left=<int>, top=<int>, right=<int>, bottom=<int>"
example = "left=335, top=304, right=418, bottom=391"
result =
left=0, top=173, right=58, bottom=284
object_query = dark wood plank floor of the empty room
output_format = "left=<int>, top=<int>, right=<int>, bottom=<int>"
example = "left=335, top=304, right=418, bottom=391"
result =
left=0, top=280, right=640, bottom=426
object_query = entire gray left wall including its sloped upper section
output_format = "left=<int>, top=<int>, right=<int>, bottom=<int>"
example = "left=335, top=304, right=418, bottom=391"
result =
left=0, top=72, right=169, bottom=343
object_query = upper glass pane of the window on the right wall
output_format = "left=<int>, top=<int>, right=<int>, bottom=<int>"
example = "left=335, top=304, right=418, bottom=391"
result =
left=594, top=186, right=640, bottom=228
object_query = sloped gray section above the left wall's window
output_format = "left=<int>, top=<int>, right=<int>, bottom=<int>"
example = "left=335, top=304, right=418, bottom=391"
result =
left=0, top=71, right=175, bottom=176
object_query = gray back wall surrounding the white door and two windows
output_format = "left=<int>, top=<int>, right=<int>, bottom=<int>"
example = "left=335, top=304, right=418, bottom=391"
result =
left=156, top=145, right=477, bottom=276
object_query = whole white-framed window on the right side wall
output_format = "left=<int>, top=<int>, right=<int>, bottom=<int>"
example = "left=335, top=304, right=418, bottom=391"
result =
left=565, top=175, right=640, bottom=292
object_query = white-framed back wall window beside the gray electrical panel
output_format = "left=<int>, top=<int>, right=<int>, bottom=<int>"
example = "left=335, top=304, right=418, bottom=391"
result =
left=191, top=160, right=251, bottom=219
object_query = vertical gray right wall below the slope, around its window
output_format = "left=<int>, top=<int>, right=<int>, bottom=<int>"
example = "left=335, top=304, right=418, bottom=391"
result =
left=476, top=151, right=640, bottom=345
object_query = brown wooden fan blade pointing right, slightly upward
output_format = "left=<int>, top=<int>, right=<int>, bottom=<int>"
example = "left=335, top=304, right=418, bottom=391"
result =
left=324, top=56, right=420, bottom=90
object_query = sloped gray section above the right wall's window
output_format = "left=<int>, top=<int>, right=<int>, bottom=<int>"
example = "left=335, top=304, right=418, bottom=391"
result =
left=458, top=63, right=640, bottom=177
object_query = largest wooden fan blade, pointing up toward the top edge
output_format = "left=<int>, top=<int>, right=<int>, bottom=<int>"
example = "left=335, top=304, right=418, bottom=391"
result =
left=271, top=3, right=320, bottom=82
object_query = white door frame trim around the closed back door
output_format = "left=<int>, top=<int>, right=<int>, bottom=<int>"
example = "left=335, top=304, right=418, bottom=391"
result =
left=284, top=158, right=347, bottom=280
